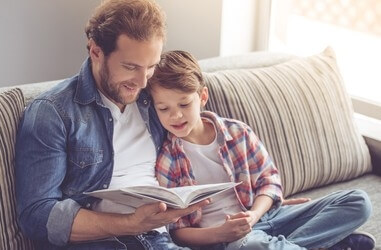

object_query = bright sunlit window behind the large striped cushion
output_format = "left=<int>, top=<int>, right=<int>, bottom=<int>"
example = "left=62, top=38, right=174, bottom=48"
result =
left=269, top=0, right=381, bottom=105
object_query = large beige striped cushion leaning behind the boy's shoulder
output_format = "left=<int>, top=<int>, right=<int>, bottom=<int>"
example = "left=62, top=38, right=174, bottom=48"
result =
left=204, top=48, right=371, bottom=196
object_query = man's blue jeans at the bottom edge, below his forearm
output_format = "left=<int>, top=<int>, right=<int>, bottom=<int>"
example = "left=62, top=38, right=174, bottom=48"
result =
left=58, top=231, right=189, bottom=250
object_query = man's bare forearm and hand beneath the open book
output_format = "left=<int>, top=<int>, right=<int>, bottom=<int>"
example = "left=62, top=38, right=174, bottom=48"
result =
left=70, top=200, right=209, bottom=242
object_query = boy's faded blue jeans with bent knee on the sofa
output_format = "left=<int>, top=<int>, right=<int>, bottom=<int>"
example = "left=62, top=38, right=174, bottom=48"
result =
left=205, top=190, right=372, bottom=250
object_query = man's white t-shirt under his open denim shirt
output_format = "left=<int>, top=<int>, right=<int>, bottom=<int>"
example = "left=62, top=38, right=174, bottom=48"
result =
left=93, top=92, right=165, bottom=231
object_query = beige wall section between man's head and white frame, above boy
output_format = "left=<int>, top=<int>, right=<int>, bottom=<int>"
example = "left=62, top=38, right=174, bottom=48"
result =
left=157, top=0, right=222, bottom=59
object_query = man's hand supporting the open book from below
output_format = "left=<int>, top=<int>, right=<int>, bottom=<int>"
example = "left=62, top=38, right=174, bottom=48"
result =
left=131, top=200, right=210, bottom=234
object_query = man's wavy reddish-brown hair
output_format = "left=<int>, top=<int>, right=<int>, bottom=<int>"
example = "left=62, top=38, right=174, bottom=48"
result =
left=85, top=0, right=166, bottom=56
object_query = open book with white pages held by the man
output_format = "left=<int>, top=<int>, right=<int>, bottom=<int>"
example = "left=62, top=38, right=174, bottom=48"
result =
left=85, top=182, right=240, bottom=208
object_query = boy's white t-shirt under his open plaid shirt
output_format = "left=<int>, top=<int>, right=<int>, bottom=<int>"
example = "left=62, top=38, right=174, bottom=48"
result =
left=182, top=122, right=242, bottom=227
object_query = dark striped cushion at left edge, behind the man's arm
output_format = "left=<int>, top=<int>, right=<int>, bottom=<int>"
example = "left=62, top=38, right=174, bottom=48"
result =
left=0, top=88, right=33, bottom=250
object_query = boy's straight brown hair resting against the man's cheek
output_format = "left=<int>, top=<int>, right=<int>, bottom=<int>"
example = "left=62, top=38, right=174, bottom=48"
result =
left=147, top=50, right=205, bottom=93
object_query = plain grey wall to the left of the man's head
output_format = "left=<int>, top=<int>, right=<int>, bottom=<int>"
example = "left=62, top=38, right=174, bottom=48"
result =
left=0, top=0, right=101, bottom=87
